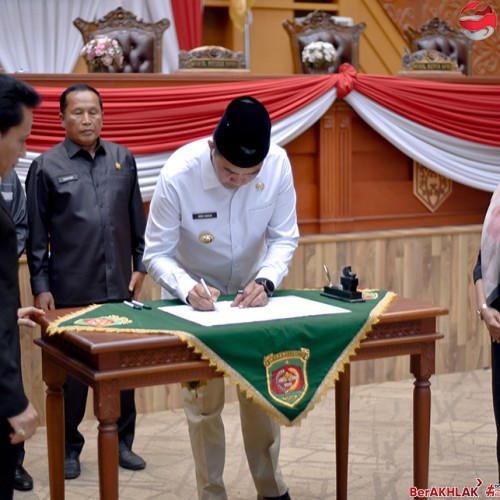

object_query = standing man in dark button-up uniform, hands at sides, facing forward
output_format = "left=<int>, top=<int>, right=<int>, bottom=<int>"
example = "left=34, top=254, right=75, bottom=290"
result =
left=26, top=84, right=146, bottom=479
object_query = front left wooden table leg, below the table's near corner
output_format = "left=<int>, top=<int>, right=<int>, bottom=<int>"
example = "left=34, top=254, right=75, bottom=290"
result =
left=94, top=380, right=120, bottom=500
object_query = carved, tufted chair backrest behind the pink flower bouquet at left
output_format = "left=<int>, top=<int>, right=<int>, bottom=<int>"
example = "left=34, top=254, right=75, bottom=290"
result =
left=73, top=7, right=170, bottom=73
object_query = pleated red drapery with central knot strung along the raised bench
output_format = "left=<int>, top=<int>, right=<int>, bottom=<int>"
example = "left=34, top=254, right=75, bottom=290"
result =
left=28, top=65, right=500, bottom=154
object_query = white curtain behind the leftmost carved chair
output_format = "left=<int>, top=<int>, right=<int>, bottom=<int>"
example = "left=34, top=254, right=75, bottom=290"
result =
left=0, top=0, right=179, bottom=73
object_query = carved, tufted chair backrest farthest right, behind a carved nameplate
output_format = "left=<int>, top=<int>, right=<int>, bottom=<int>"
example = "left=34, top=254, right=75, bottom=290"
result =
left=404, top=17, right=473, bottom=75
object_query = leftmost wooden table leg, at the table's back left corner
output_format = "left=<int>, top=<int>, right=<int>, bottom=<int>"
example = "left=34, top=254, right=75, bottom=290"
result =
left=42, top=351, right=66, bottom=500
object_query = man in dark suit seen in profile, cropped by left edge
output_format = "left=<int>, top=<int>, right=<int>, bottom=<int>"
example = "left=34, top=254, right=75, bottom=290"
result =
left=0, top=74, right=43, bottom=500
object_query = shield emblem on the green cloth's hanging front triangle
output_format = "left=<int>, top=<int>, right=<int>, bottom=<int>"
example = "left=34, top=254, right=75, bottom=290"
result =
left=264, top=347, right=310, bottom=408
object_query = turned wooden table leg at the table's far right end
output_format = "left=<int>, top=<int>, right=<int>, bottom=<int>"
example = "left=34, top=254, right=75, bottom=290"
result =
left=410, top=342, right=435, bottom=500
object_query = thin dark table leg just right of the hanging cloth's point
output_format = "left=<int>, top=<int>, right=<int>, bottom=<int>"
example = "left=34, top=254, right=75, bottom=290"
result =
left=335, top=363, right=351, bottom=500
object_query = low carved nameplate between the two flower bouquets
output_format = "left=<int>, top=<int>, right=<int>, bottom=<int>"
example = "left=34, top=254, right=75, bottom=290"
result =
left=179, top=45, right=246, bottom=69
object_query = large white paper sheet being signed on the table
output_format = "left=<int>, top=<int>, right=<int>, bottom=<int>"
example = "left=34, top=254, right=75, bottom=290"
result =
left=158, top=295, right=350, bottom=326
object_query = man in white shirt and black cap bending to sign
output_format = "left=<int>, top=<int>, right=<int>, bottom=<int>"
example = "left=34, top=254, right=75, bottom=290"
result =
left=144, top=96, right=299, bottom=500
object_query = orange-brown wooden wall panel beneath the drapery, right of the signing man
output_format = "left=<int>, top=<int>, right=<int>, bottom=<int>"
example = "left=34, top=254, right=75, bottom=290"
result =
left=285, top=100, right=491, bottom=234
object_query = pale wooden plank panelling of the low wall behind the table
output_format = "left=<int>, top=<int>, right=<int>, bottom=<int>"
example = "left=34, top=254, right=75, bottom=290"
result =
left=20, top=225, right=490, bottom=422
